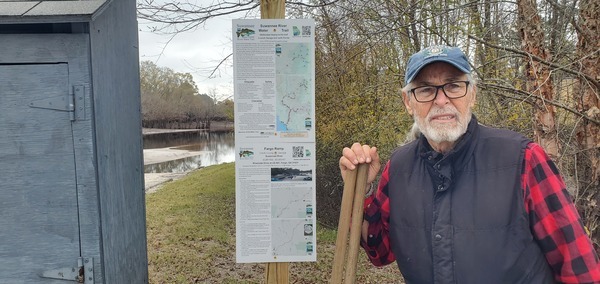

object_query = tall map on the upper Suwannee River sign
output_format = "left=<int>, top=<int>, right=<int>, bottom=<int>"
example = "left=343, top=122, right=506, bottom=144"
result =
left=275, top=43, right=313, bottom=132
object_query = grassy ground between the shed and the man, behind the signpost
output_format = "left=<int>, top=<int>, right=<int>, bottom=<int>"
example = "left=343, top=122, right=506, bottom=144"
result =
left=146, top=163, right=401, bottom=284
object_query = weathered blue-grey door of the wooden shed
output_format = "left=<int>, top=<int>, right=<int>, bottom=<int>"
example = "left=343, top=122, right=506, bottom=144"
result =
left=0, top=63, right=80, bottom=283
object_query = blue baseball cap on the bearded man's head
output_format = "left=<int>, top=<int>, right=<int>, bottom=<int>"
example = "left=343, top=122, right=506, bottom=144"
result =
left=404, top=45, right=471, bottom=85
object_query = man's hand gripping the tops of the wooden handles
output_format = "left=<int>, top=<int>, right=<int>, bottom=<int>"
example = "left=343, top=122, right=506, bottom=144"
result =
left=340, top=143, right=381, bottom=187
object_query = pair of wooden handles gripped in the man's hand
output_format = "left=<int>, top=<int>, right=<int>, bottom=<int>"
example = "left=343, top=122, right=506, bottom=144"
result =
left=331, top=164, right=369, bottom=284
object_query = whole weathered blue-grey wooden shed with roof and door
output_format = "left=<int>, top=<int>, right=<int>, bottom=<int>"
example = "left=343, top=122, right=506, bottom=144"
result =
left=0, top=0, right=148, bottom=284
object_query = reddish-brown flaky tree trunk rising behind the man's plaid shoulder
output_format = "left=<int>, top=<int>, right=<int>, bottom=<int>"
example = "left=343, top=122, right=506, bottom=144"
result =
left=517, top=0, right=559, bottom=159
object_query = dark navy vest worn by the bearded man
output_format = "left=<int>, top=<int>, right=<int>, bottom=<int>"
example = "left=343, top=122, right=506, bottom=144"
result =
left=388, top=117, right=554, bottom=284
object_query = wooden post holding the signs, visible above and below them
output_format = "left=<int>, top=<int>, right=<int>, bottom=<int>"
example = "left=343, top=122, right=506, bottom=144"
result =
left=260, top=0, right=290, bottom=284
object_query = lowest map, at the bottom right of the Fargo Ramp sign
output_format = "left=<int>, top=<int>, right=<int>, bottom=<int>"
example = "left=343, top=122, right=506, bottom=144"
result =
left=271, top=219, right=314, bottom=257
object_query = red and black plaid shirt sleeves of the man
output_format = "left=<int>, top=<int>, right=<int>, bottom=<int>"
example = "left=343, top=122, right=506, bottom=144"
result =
left=361, top=143, right=600, bottom=283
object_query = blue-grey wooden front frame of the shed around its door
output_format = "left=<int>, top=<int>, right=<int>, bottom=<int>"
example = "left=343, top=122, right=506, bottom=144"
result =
left=0, top=34, right=104, bottom=283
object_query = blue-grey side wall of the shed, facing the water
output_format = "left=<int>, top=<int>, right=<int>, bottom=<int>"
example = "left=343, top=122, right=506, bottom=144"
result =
left=90, top=0, right=148, bottom=283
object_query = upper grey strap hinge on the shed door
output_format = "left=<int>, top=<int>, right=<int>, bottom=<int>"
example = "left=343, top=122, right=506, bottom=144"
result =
left=29, top=85, right=88, bottom=121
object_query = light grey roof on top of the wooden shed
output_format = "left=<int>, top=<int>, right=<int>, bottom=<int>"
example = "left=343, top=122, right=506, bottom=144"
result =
left=0, top=0, right=107, bottom=18
